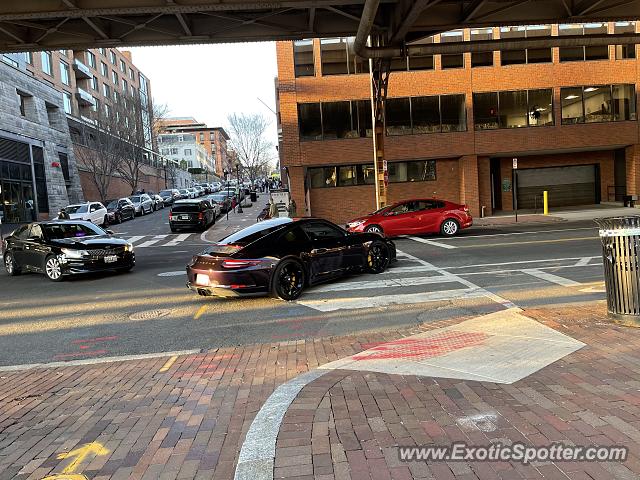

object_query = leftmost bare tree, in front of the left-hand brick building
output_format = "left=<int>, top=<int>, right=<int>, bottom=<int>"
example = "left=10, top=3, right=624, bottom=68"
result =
left=72, top=104, right=123, bottom=202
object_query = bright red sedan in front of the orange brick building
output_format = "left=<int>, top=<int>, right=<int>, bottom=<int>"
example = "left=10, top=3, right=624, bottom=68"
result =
left=347, top=198, right=473, bottom=237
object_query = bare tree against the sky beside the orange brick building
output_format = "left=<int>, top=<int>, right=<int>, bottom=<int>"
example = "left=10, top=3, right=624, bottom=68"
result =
left=227, top=113, right=274, bottom=182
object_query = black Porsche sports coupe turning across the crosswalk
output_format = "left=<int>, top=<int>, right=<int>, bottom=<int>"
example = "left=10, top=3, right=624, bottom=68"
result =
left=187, top=218, right=396, bottom=300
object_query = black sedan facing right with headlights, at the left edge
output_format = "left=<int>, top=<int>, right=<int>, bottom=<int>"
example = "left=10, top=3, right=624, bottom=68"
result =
left=3, top=220, right=136, bottom=281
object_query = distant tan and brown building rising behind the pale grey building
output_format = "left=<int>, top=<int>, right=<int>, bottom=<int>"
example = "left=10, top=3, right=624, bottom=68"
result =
left=160, top=117, right=232, bottom=177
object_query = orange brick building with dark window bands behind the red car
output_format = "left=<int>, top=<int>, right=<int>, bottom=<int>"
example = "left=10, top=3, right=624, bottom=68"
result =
left=277, top=22, right=640, bottom=223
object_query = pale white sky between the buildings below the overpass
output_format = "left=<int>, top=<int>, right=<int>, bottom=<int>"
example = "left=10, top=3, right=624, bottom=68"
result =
left=129, top=42, right=278, bottom=145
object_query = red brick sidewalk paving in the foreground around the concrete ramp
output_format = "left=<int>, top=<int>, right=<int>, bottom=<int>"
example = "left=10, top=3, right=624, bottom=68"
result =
left=0, top=303, right=640, bottom=480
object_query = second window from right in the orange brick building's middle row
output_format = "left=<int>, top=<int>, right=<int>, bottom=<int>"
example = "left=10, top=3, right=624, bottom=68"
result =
left=473, top=89, right=553, bottom=130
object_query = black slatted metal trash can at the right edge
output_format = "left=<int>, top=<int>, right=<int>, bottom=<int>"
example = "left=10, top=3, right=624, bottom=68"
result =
left=595, top=216, right=640, bottom=325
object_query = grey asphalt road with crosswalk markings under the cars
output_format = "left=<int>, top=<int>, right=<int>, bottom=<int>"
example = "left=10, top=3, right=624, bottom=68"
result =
left=0, top=206, right=604, bottom=366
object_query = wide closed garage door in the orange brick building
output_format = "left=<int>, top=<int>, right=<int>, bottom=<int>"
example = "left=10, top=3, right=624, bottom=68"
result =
left=518, top=165, right=598, bottom=208
